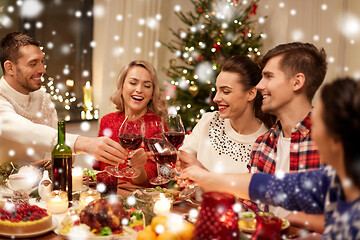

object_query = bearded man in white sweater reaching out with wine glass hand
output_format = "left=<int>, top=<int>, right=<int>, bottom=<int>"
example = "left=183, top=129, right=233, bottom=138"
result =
left=0, top=32, right=127, bottom=165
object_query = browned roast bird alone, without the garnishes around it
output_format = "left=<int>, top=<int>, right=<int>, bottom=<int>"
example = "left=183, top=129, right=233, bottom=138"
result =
left=80, top=199, right=130, bottom=232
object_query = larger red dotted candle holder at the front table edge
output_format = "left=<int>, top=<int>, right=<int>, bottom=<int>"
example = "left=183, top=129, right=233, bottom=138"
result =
left=194, top=192, right=240, bottom=240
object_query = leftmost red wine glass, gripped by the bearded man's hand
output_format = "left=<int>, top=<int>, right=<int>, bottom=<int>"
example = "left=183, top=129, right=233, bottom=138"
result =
left=105, top=117, right=145, bottom=178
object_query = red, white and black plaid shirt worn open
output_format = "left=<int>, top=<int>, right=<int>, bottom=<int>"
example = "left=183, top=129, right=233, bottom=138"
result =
left=248, top=112, right=320, bottom=174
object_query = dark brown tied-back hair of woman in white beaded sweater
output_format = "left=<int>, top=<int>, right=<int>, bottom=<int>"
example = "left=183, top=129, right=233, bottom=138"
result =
left=221, top=55, right=276, bottom=128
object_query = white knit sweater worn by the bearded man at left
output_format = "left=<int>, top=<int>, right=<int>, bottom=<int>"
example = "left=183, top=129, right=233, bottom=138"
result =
left=0, top=77, right=78, bottom=165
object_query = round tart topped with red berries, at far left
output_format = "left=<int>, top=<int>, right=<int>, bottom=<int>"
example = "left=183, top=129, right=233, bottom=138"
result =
left=0, top=202, right=52, bottom=234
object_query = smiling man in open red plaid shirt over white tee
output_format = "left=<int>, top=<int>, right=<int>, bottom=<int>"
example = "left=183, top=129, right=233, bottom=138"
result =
left=248, top=42, right=327, bottom=231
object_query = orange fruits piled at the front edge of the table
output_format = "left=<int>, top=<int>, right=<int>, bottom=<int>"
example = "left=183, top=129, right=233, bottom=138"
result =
left=136, top=215, right=195, bottom=240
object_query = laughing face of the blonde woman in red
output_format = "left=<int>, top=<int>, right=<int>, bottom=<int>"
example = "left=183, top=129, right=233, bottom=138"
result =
left=122, top=66, right=153, bottom=117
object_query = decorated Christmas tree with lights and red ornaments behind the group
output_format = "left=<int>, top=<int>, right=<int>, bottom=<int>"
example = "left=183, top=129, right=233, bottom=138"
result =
left=164, top=0, right=263, bottom=131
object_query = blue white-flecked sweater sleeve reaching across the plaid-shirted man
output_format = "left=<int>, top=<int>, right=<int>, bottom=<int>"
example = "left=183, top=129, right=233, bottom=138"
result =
left=249, top=169, right=330, bottom=214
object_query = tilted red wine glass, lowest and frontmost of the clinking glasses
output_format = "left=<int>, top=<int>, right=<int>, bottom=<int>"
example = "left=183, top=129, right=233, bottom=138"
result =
left=144, top=133, right=177, bottom=185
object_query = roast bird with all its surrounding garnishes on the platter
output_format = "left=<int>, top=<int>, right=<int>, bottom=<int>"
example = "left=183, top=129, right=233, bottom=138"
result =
left=59, top=198, right=144, bottom=237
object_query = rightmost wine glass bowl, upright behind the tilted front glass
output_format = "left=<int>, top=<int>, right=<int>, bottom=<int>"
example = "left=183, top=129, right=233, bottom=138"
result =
left=164, top=114, right=185, bottom=149
